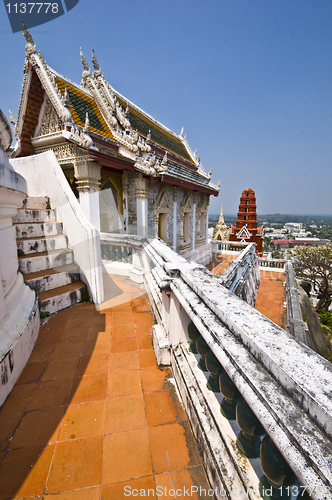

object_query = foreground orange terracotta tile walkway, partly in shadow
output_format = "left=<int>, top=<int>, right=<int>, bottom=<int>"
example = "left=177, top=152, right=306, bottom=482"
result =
left=0, top=278, right=211, bottom=500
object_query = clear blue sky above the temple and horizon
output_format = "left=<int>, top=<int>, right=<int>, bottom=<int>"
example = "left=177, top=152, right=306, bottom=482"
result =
left=0, top=0, right=332, bottom=214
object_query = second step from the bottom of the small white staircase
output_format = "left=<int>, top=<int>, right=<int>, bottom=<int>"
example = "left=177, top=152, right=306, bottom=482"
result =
left=23, top=264, right=80, bottom=293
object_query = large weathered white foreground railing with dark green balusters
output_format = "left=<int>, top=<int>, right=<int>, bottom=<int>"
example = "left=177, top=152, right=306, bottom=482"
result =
left=99, top=235, right=332, bottom=500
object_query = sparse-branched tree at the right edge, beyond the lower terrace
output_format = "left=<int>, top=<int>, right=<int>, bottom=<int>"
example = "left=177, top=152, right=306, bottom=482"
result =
left=293, top=245, right=332, bottom=312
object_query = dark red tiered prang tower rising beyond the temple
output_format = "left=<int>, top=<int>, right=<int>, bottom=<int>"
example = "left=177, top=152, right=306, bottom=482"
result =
left=229, top=188, right=263, bottom=256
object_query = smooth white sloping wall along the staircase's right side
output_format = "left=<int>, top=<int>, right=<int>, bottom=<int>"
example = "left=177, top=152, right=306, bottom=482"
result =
left=11, top=151, right=104, bottom=304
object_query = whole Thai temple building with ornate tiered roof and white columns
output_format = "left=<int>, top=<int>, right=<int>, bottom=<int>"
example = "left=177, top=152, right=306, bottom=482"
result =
left=12, top=26, right=220, bottom=263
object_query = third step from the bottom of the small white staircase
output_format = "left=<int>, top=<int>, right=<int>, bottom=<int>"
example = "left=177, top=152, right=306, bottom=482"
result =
left=18, top=248, right=74, bottom=274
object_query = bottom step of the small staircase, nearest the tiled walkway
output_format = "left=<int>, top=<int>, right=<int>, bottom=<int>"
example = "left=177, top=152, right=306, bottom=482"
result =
left=39, top=281, right=86, bottom=314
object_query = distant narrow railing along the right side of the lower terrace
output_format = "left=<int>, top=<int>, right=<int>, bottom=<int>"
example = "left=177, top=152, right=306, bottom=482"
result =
left=285, top=260, right=308, bottom=345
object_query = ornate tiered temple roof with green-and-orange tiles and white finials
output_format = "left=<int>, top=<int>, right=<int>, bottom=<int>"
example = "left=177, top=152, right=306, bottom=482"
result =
left=14, top=25, right=220, bottom=196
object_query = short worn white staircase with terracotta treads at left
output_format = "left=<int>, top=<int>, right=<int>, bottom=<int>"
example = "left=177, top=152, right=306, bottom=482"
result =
left=13, top=197, right=86, bottom=314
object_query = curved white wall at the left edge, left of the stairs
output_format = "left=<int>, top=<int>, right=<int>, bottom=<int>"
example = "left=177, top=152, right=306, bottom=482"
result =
left=0, top=110, right=40, bottom=407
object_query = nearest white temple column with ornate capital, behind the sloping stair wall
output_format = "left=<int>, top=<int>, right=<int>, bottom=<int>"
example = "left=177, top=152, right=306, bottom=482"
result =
left=74, top=159, right=101, bottom=231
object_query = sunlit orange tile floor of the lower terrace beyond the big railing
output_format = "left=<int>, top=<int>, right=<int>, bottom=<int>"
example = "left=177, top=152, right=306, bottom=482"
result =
left=255, top=270, right=286, bottom=329
